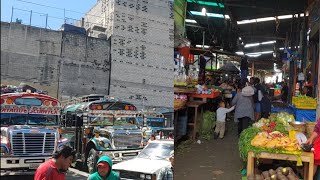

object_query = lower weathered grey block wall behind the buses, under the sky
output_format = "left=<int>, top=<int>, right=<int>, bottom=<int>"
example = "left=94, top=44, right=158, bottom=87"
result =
left=1, top=22, right=111, bottom=99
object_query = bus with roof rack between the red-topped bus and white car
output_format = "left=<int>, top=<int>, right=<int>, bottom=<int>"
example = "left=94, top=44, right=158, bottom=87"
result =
left=62, top=95, right=143, bottom=173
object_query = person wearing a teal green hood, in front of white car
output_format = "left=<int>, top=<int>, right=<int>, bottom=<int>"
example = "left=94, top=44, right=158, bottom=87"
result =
left=88, top=156, right=120, bottom=180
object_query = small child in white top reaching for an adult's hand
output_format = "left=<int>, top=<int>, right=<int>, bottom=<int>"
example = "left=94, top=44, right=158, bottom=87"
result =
left=214, top=101, right=235, bottom=139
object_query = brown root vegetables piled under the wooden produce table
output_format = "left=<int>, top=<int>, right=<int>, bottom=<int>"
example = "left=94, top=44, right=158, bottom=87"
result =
left=248, top=167, right=299, bottom=180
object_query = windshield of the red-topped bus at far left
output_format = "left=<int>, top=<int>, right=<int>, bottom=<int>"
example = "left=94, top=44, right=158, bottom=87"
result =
left=1, top=113, right=59, bottom=126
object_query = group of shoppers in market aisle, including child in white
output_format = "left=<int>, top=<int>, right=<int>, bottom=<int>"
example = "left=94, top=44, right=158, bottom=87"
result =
left=214, top=77, right=288, bottom=138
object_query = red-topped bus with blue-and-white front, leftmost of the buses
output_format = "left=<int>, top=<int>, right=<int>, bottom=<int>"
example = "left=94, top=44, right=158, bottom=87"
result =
left=1, top=93, right=68, bottom=173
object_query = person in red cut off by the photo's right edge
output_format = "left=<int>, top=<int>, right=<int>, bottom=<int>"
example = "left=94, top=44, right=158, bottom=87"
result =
left=306, top=118, right=320, bottom=178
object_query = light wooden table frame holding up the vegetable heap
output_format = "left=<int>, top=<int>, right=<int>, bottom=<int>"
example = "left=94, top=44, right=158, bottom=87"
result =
left=247, top=152, right=314, bottom=180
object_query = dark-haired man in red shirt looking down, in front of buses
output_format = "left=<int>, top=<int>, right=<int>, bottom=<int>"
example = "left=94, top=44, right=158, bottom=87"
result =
left=34, top=146, right=76, bottom=180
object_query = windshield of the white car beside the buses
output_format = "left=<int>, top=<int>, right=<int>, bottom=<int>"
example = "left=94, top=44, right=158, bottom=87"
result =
left=137, top=143, right=174, bottom=159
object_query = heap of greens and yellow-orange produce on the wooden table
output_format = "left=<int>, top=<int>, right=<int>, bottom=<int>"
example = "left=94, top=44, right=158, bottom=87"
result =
left=239, top=112, right=301, bottom=161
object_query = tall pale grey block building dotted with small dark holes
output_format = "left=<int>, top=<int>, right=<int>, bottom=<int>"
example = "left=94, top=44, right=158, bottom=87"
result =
left=83, top=0, right=174, bottom=109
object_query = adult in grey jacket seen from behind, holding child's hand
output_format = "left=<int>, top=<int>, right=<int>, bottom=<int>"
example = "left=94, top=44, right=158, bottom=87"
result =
left=231, top=83, right=254, bottom=136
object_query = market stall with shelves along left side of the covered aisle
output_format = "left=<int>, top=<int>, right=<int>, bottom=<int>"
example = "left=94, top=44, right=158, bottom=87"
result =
left=174, top=52, right=220, bottom=141
